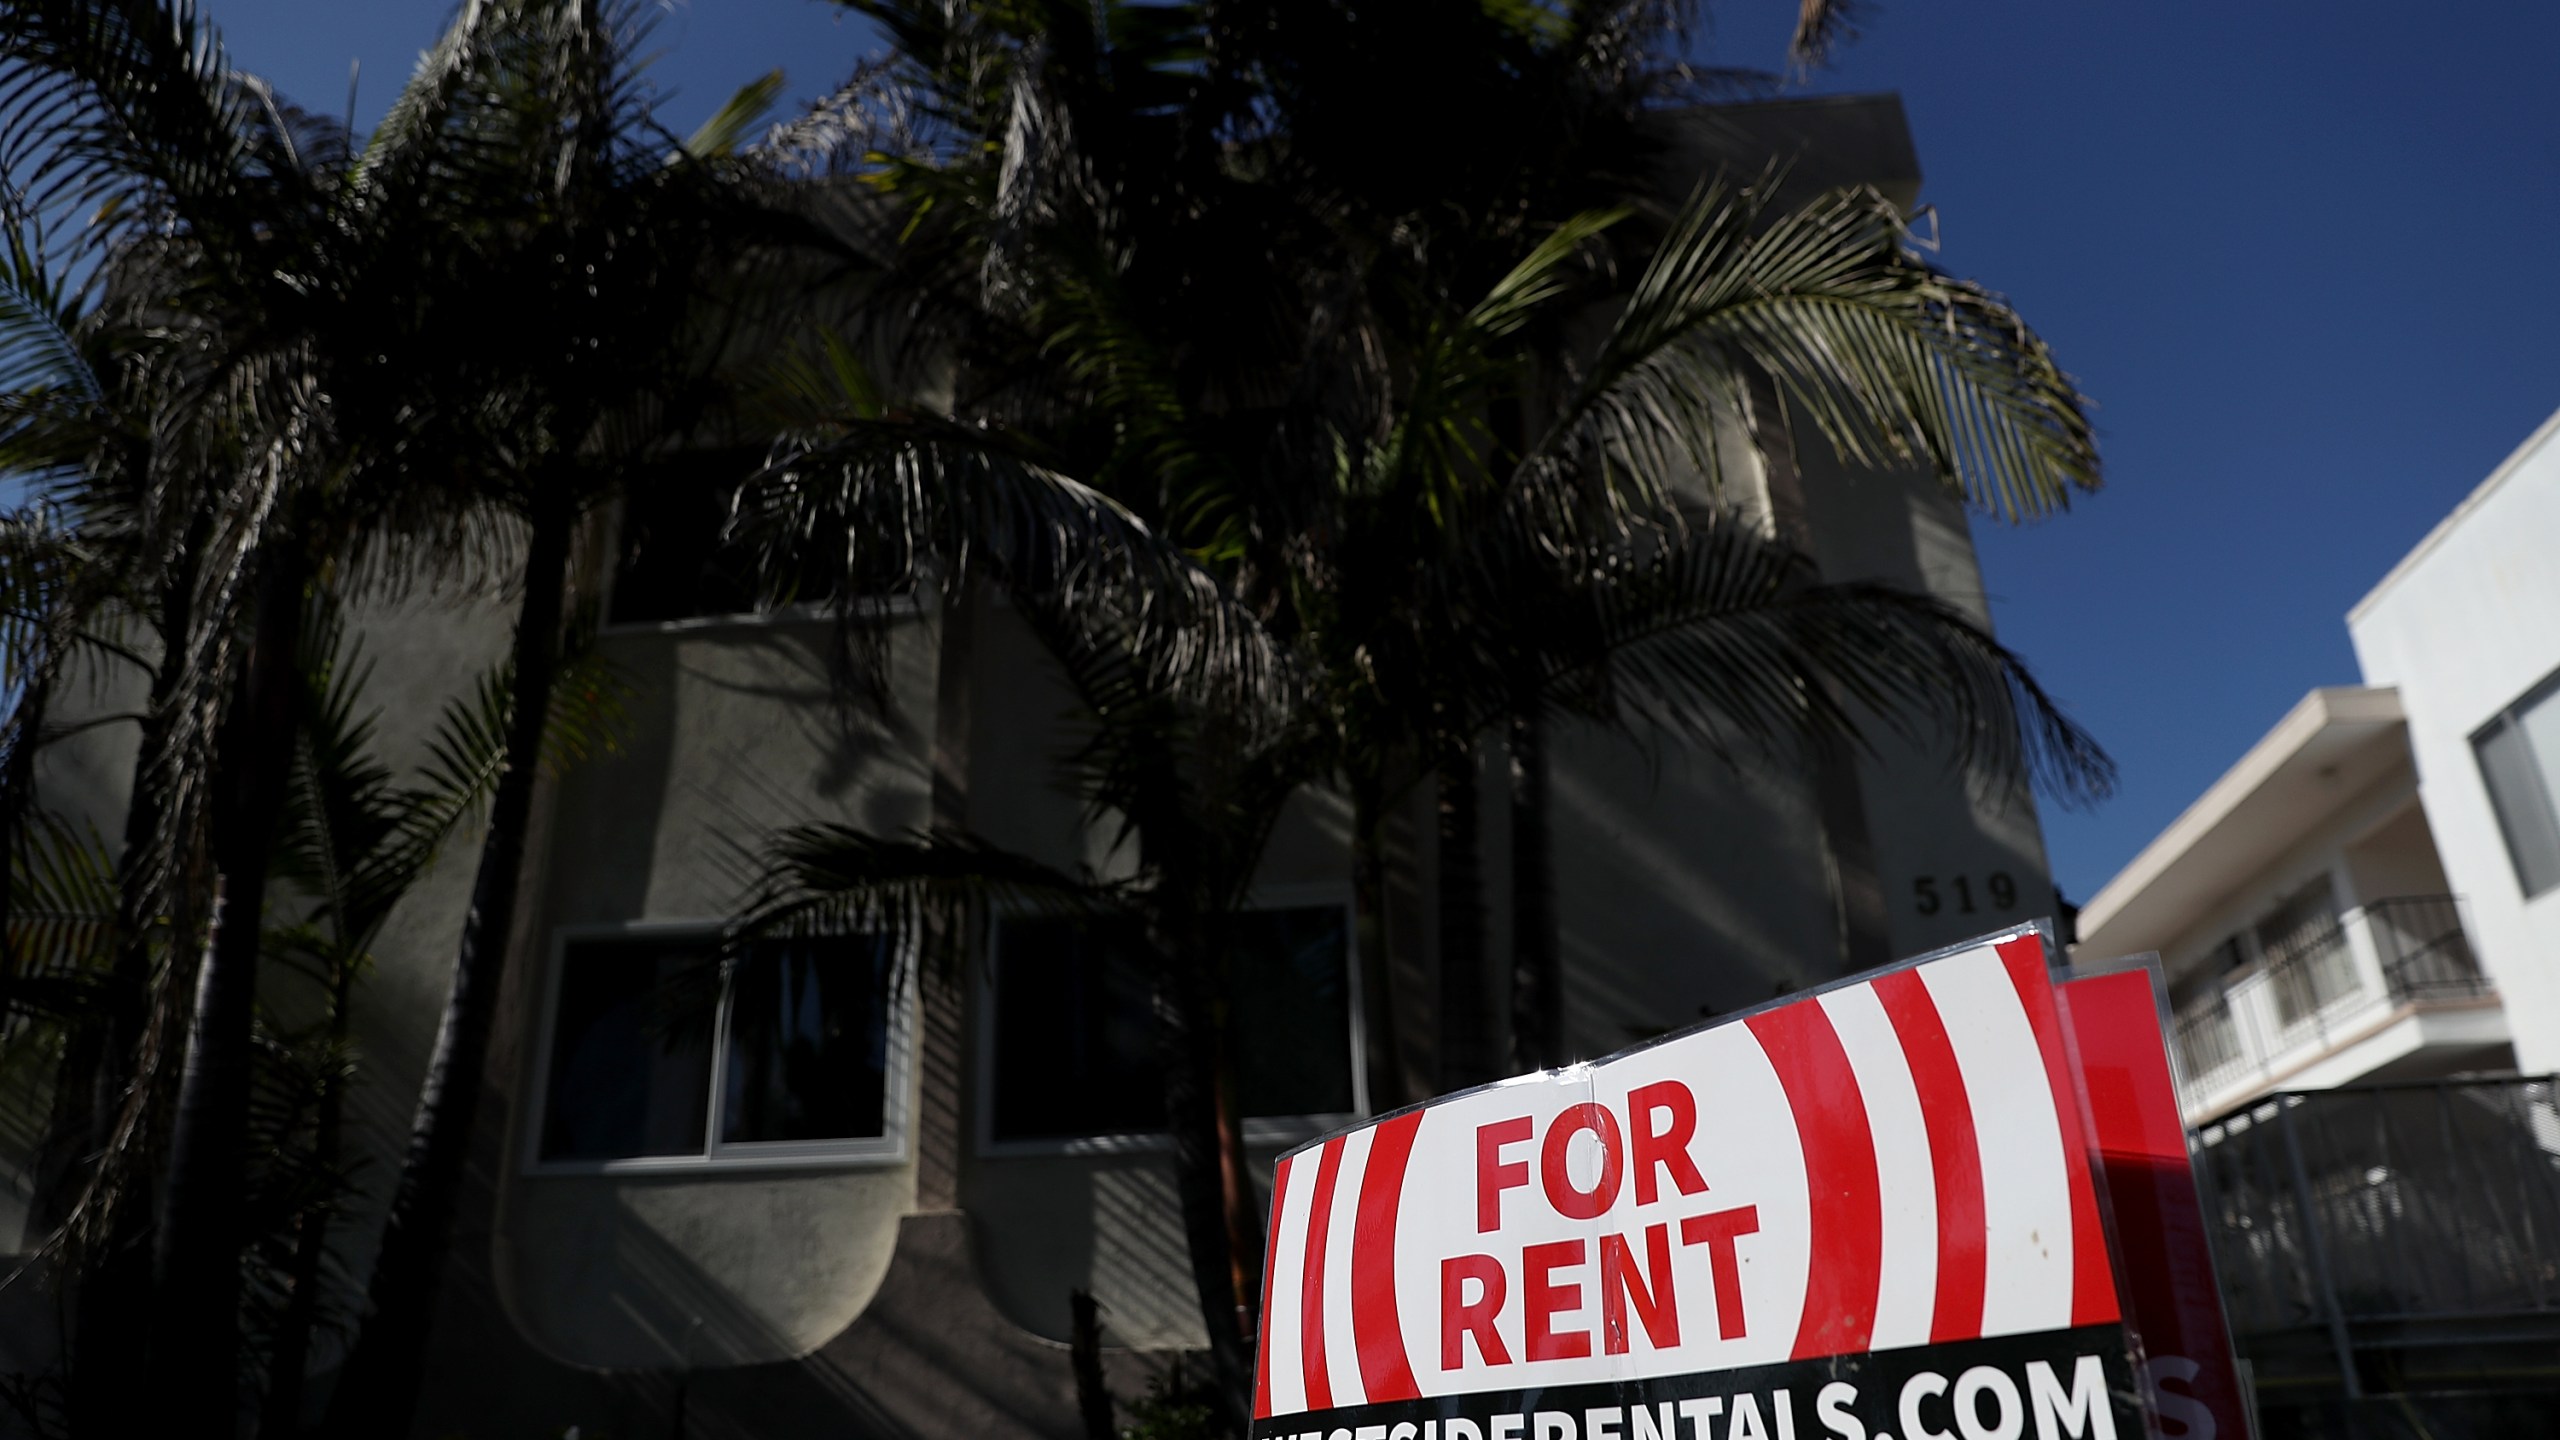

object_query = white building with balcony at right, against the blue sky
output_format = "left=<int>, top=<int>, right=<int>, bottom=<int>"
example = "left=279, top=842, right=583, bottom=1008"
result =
left=2074, top=397, right=2560, bottom=1122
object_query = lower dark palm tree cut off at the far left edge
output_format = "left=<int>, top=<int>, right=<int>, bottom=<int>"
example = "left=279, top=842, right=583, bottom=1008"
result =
left=0, top=257, right=225, bottom=1427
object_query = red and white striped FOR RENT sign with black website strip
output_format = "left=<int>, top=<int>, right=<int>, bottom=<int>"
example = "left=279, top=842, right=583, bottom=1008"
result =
left=1254, top=933, right=2143, bottom=1440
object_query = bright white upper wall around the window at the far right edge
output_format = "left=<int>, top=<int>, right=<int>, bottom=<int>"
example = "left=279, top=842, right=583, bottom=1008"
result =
left=2348, top=404, right=2560, bottom=1074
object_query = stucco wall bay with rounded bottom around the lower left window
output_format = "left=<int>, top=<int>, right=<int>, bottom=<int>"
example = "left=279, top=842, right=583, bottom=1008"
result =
left=497, top=615, right=934, bottom=1368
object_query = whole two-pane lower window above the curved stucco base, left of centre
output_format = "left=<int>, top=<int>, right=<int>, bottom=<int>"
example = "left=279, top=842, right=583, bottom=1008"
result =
left=532, top=928, right=904, bottom=1168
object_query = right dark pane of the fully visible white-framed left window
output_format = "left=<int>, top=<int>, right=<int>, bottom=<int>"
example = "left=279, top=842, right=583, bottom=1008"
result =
left=719, top=935, right=891, bottom=1143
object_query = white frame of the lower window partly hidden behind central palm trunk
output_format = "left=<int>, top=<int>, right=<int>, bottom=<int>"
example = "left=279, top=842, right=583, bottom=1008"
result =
left=970, top=884, right=1370, bottom=1161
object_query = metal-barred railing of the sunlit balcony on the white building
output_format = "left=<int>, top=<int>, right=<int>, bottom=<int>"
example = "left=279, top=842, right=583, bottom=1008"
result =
left=2176, top=894, right=2491, bottom=1104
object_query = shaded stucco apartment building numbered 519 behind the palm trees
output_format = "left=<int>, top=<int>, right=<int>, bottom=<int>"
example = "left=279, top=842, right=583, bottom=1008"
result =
left=5, top=95, right=2053, bottom=1437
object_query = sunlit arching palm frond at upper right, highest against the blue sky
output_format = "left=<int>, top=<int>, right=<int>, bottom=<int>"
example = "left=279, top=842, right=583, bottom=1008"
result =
left=1521, top=174, right=2099, bottom=520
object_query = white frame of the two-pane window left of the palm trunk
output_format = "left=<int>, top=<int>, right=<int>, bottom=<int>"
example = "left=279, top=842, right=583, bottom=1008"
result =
left=517, top=920, right=916, bottom=1179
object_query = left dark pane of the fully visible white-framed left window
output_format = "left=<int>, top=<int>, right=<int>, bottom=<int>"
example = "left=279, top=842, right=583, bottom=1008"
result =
left=543, top=938, right=719, bottom=1161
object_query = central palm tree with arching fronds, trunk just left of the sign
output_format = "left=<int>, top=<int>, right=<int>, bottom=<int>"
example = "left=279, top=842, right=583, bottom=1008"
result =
left=740, top=190, right=2092, bottom=1434
